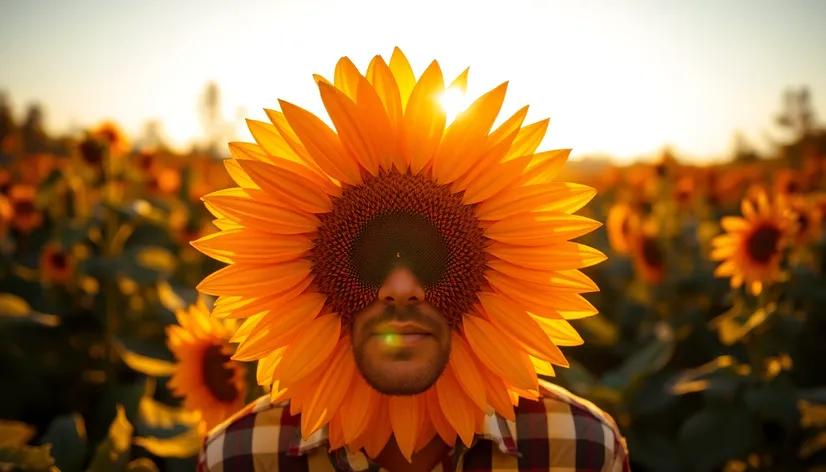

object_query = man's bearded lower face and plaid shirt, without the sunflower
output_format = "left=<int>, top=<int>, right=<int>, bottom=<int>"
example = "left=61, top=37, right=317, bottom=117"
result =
left=198, top=267, right=630, bottom=472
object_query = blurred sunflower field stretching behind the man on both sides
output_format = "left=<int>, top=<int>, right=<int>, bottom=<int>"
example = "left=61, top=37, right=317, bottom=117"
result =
left=0, top=92, right=826, bottom=472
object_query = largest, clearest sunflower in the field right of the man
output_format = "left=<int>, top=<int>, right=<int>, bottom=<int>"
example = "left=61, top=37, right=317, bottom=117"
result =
left=711, top=191, right=794, bottom=295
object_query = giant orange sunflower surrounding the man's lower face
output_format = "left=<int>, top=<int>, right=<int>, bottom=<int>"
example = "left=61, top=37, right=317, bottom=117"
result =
left=193, top=49, right=605, bottom=458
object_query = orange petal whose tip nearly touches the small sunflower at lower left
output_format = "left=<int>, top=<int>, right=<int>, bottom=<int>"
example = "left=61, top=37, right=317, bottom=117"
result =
left=232, top=293, right=326, bottom=362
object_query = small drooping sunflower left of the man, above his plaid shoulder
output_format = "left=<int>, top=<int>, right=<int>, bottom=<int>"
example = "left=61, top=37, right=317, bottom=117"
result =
left=166, top=300, right=247, bottom=431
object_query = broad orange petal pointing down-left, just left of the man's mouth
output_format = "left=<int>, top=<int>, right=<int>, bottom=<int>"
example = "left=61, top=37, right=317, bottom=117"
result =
left=275, top=314, right=341, bottom=387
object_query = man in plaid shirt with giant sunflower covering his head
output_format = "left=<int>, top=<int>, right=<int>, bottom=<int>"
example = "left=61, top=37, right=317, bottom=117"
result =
left=193, top=48, right=628, bottom=472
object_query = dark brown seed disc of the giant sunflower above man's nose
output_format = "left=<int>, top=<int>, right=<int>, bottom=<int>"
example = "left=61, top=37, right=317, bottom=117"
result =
left=310, top=170, right=487, bottom=325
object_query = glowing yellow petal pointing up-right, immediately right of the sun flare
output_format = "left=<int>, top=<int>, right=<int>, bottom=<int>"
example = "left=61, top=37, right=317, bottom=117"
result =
left=433, top=82, right=508, bottom=184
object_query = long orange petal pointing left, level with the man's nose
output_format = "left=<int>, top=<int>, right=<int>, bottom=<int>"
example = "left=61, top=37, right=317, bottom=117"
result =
left=197, top=259, right=311, bottom=297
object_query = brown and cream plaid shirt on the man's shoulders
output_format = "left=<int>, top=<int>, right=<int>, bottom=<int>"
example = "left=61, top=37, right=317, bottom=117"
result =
left=197, top=380, right=630, bottom=472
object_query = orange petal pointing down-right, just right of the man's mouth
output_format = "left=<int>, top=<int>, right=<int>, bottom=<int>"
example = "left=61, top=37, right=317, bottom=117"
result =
left=462, top=315, right=536, bottom=389
